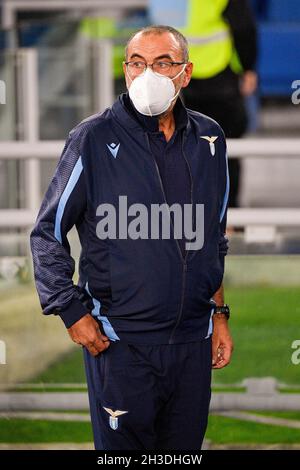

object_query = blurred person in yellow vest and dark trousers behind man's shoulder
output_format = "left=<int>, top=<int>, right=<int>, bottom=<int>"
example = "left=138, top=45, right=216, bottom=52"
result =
left=179, top=0, right=257, bottom=207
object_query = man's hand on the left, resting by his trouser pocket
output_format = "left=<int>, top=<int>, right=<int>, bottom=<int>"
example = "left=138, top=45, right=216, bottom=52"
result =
left=68, top=313, right=110, bottom=356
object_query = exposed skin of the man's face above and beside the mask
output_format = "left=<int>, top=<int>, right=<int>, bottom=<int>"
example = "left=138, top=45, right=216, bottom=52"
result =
left=123, top=32, right=193, bottom=97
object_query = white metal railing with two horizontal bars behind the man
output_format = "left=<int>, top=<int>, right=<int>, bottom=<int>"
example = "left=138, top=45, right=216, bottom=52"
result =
left=0, top=138, right=300, bottom=228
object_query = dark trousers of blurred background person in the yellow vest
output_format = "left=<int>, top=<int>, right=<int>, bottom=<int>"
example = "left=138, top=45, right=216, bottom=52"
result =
left=183, top=67, right=248, bottom=207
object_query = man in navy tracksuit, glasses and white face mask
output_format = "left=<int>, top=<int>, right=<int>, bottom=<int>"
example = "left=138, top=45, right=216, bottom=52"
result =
left=31, top=27, right=232, bottom=450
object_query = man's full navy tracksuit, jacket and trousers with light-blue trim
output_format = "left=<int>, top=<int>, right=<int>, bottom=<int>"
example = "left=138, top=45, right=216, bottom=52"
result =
left=31, top=92, right=229, bottom=449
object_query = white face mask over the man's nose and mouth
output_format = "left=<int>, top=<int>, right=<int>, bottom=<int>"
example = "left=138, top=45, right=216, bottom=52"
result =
left=129, top=64, right=186, bottom=116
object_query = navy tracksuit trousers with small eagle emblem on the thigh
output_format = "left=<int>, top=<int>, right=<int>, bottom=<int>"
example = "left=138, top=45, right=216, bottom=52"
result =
left=83, top=337, right=211, bottom=450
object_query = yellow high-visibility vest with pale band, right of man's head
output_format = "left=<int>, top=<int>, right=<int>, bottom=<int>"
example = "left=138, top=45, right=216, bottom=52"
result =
left=179, top=0, right=242, bottom=78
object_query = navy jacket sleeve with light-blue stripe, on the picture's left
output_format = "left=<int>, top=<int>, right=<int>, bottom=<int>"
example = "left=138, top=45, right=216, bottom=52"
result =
left=30, top=127, right=92, bottom=328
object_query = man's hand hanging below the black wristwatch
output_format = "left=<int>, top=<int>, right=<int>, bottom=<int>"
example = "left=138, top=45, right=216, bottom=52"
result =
left=212, top=313, right=233, bottom=369
